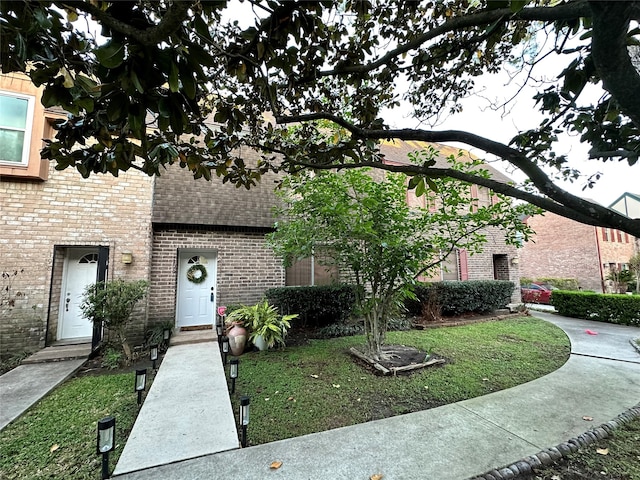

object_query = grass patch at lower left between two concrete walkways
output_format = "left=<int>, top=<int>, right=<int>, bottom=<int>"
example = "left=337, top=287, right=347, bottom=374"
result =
left=0, top=373, right=138, bottom=480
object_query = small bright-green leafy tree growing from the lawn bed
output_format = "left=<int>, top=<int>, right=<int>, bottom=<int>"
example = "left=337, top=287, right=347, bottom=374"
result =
left=269, top=159, right=534, bottom=360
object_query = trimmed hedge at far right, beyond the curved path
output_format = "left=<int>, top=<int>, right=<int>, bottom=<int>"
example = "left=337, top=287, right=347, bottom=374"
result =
left=551, top=290, right=640, bottom=326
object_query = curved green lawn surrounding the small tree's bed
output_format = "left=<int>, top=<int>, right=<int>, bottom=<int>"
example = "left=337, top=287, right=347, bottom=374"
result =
left=232, top=317, right=570, bottom=445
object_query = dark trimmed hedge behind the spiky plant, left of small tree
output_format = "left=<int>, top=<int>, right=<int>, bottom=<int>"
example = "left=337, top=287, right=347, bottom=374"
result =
left=265, top=284, right=356, bottom=327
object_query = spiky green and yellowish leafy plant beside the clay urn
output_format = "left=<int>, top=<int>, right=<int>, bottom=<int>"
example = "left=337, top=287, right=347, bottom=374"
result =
left=227, top=299, right=298, bottom=350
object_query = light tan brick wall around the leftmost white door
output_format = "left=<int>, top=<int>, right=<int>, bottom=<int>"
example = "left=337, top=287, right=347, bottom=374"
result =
left=0, top=166, right=152, bottom=355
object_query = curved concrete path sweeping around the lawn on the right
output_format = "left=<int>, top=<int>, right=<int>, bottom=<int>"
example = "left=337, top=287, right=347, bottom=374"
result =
left=117, top=313, right=640, bottom=480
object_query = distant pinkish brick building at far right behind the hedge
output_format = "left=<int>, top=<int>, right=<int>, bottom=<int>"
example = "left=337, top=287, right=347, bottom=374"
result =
left=520, top=194, right=637, bottom=292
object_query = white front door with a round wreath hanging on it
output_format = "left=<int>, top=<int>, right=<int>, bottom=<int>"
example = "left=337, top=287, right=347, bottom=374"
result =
left=176, top=251, right=216, bottom=327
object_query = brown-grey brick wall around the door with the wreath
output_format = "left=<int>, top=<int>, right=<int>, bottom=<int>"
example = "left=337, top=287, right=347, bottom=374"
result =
left=149, top=227, right=285, bottom=324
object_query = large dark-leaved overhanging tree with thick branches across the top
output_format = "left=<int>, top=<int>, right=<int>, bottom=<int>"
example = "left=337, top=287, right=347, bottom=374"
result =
left=0, top=0, right=640, bottom=236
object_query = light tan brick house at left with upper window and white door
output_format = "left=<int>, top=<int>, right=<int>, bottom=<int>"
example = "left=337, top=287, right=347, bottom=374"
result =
left=0, top=75, right=153, bottom=355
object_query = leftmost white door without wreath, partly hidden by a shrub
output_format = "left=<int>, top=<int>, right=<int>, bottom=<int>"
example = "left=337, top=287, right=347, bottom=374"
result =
left=57, top=248, right=98, bottom=340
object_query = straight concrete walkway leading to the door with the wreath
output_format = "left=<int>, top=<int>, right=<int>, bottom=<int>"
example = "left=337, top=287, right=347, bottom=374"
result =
left=114, top=341, right=239, bottom=476
